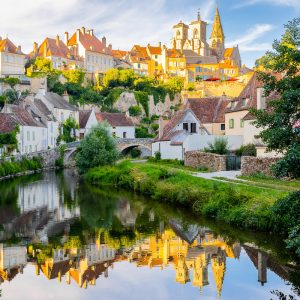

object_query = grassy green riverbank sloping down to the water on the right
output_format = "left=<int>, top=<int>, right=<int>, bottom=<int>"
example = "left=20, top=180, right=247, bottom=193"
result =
left=85, top=161, right=299, bottom=255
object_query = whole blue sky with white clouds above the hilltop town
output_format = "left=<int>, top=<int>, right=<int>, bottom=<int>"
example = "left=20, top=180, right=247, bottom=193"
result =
left=0, top=0, right=300, bottom=67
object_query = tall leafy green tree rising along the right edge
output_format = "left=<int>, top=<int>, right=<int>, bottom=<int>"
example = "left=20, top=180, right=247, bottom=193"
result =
left=252, top=18, right=300, bottom=177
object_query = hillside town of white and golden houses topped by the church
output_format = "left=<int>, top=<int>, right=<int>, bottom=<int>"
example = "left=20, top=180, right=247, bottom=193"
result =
left=0, top=7, right=275, bottom=164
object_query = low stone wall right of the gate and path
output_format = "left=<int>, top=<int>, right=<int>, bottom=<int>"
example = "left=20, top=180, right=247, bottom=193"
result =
left=241, top=156, right=280, bottom=176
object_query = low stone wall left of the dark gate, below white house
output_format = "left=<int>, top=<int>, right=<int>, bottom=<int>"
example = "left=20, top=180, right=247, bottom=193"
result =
left=184, top=151, right=226, bottom=171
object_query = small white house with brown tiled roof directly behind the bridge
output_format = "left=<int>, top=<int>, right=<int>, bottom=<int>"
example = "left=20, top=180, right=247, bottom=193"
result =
left=96, top=112, right=135, bottom=139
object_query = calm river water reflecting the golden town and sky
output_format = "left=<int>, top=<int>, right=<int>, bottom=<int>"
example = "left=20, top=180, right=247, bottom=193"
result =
left=0, top=171, right=300, bottom=300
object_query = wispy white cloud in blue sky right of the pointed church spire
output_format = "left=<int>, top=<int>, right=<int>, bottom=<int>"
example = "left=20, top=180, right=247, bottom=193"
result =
left=227, top=24, right=274, bottom=52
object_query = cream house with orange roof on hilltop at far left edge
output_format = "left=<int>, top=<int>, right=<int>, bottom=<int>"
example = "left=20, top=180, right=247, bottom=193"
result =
left=0, top=37, right=25, bottom=77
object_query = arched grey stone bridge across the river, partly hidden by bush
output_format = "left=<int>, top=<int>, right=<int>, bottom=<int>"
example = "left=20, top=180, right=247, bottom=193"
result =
left=64, top=138, right=154, bottom=166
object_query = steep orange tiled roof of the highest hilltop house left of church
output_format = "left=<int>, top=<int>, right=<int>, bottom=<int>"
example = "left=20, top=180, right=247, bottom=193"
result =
left=68, top=30, right=110, bottom=54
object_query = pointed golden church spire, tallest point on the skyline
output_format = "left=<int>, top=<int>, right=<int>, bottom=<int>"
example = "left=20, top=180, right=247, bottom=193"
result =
left=210, top=6, right=225, bottom=57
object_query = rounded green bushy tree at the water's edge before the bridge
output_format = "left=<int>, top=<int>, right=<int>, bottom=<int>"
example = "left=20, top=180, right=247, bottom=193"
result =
left=76, top=123, right=119, bottom=174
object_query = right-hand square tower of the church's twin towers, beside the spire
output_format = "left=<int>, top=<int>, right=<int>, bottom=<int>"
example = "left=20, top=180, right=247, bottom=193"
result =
left=190, top=12, right=208, bottom=56
